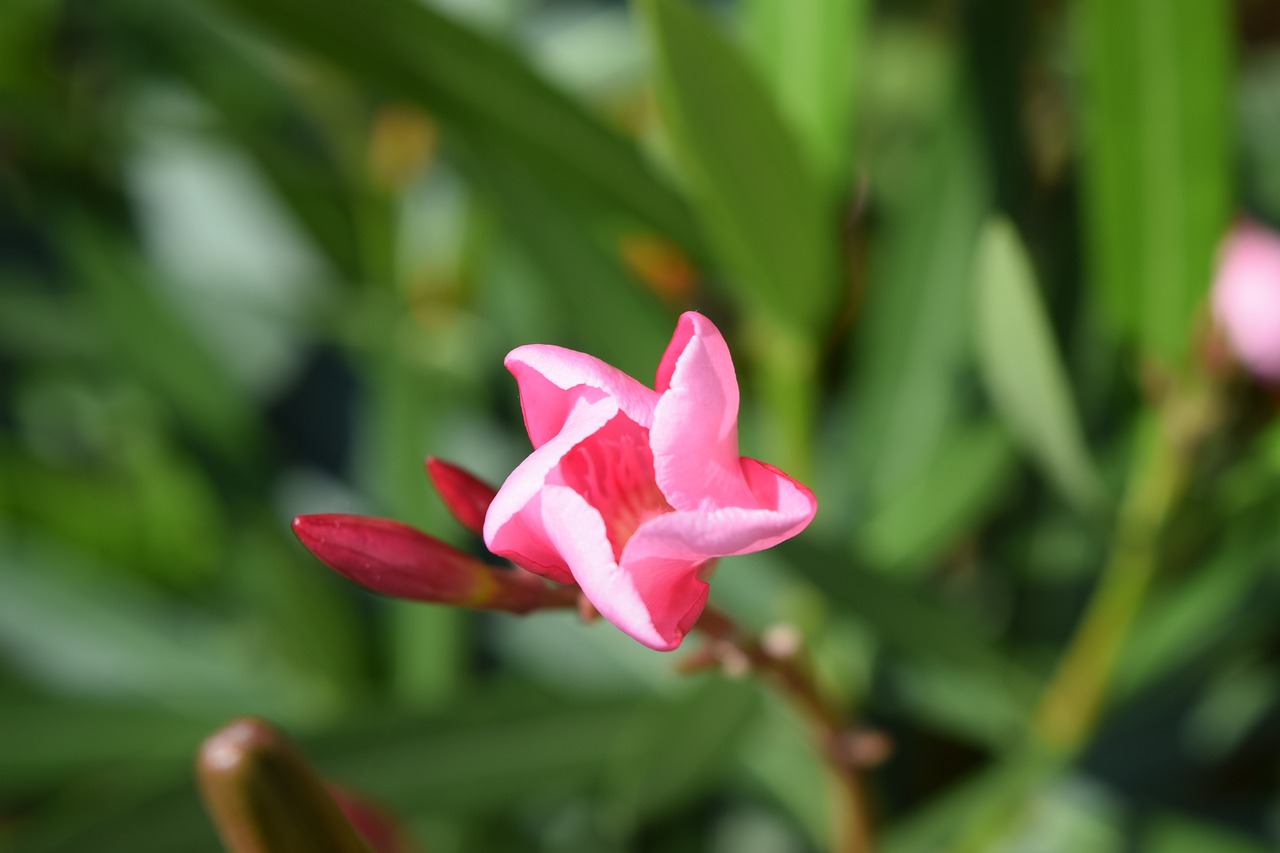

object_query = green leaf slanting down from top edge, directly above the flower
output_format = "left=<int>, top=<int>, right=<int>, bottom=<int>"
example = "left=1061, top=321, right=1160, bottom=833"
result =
left=637, top=0, right=840, bottom=330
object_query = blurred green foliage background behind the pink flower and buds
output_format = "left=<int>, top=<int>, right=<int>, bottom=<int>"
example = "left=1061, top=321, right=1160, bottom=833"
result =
left=0, top=0, right=1280, bottom=853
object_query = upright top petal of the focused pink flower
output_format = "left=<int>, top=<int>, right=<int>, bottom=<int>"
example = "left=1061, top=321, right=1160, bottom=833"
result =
left=649, top=311, right=754, bottom=511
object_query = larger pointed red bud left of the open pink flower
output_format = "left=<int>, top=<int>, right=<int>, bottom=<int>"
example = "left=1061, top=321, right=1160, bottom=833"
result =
left=293, top=515, right=573, bottom=613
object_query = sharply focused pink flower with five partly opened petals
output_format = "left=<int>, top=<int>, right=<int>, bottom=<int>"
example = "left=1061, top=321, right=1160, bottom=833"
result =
left=484, top=313, right=817, bottom=651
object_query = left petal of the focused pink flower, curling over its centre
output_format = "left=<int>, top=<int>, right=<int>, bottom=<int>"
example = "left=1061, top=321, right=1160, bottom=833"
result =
left=484, top=397, right=618, bottom=583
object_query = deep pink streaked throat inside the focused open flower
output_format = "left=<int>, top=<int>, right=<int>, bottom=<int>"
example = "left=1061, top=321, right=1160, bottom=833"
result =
left=559, top=415, right=672, bottom=560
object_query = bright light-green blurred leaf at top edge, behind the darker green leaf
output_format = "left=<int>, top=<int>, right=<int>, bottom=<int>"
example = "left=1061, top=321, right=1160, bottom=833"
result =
left=745, top=0, right=870, bottom=199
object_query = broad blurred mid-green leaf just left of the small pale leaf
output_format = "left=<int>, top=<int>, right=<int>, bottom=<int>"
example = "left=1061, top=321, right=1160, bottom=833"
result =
left=844, top=92, right=988, bottom=504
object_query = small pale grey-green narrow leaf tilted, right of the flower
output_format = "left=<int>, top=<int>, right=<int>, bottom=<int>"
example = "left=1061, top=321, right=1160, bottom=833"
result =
left=973, top=219, right=1102, bottom=512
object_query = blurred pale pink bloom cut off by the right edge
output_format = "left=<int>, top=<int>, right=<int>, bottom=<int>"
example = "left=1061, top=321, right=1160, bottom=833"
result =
left=1213, top=222, right=1280, bottom=383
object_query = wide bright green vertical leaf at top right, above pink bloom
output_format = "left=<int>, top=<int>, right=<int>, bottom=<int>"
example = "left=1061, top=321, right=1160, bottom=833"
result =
left=1078, top=0, right=1233, bottom=364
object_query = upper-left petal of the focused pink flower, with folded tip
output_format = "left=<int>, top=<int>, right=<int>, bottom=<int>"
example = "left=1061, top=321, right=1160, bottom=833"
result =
left=506, top=345, right=658, bottom=448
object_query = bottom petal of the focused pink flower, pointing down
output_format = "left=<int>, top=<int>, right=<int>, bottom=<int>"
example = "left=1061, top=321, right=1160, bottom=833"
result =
left=541, top=485, right=708, bottom=652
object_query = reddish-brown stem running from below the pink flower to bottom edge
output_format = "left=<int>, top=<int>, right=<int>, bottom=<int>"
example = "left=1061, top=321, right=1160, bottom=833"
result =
left=696, top=606, right=872, bottom=853
